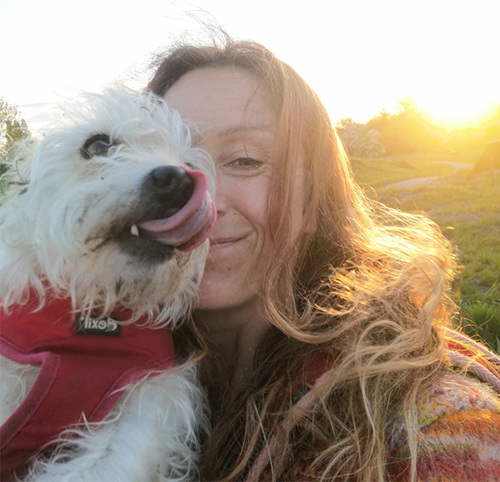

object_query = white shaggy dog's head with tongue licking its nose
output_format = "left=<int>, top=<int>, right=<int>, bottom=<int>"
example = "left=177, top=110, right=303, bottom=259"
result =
left=0, top=90, right=215, bottom=322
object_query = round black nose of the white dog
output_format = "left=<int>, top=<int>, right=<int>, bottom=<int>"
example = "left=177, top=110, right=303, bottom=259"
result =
left=142, top=166, right=194, bottom=217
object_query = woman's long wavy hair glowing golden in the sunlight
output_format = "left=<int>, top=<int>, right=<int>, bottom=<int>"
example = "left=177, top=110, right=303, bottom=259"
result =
left=148, top=32, right=466, bottom=480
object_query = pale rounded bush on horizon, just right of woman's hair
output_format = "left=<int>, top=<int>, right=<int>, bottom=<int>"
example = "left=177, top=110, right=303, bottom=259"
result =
left=335, top=118, right=385, bottom=158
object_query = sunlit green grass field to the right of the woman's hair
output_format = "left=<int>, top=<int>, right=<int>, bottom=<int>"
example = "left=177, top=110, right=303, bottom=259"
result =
left=353, top=152, right=500, bottom=353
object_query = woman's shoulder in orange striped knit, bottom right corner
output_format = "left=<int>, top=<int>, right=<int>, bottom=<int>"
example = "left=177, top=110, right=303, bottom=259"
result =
left=388, top=369, right=500, bottom=481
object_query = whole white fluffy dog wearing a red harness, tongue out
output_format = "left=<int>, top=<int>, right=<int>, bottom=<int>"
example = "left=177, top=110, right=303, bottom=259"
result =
left=0, top=89, right=215, bottom=482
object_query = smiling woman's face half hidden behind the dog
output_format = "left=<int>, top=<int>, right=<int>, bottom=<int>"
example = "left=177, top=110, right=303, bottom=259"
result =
left=165, top=67, right=304, bottom=316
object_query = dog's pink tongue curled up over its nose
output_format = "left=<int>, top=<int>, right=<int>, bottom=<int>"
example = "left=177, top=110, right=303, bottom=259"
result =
left=137, top=169, right=216, bottom=251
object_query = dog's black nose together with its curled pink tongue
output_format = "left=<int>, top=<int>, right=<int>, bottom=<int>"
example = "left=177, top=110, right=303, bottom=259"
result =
left=137, top=166, right=216, bottom=251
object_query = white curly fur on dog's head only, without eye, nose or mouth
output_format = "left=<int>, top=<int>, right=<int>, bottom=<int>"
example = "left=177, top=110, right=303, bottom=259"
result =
left=0, top=91, right=215, bottom=324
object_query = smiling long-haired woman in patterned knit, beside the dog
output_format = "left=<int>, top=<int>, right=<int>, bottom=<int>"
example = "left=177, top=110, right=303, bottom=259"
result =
left=149, top=32, right=500, bottom=481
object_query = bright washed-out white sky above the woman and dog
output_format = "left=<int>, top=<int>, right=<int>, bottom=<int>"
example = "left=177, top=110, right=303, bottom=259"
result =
left=0, top=0, right=500, bottom=131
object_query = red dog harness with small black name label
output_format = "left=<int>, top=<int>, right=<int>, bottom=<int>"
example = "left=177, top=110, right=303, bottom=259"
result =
left=0, top=300, right=176, bottom=480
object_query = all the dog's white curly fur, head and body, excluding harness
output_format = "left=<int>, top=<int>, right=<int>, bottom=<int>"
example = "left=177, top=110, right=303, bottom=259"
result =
left=0, top=89, right=215, bottom=481
